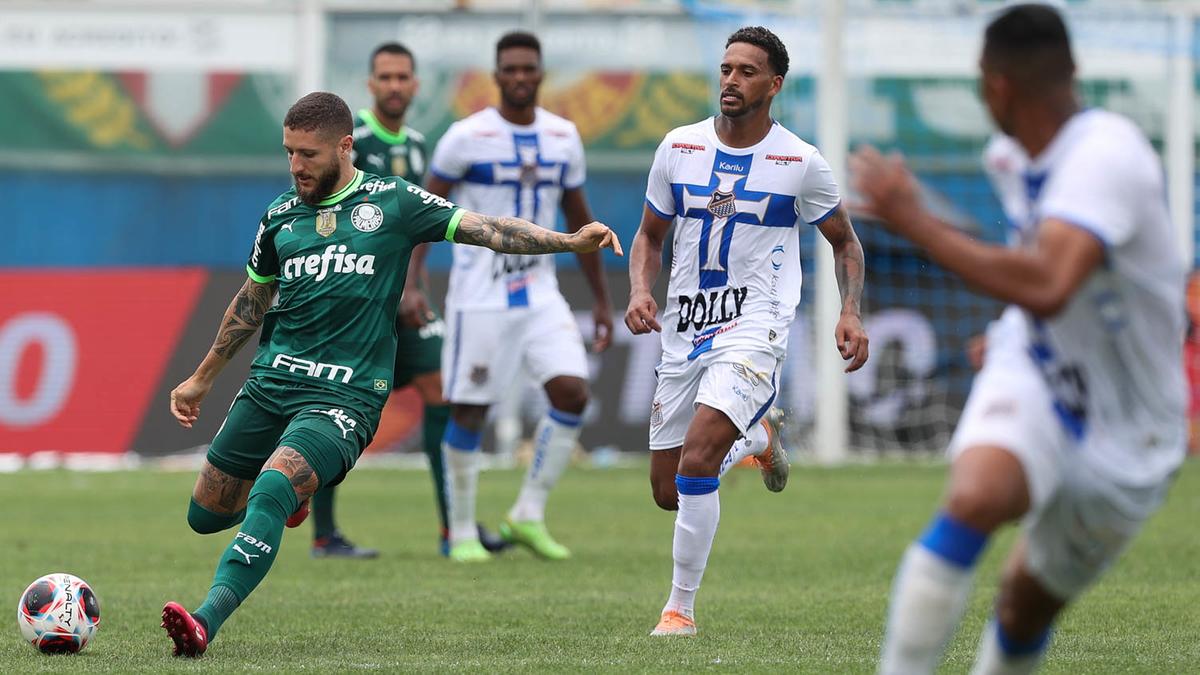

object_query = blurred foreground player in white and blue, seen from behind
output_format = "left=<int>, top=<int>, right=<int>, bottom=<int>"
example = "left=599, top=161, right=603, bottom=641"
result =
left=852, top=5, right=1187, bottom=674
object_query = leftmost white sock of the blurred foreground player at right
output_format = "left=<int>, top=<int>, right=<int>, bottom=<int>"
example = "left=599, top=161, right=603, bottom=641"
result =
left=880, top=543, right=973, bottom=675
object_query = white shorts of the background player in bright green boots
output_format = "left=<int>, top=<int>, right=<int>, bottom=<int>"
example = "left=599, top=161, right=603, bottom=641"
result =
left=442, top=298, right=588, bottom=405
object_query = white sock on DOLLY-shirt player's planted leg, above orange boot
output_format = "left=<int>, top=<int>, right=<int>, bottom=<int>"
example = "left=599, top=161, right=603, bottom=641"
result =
left=662, top=478, right=721, bottom=616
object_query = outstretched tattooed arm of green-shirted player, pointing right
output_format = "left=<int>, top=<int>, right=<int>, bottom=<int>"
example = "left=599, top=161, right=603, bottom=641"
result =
left=454, top=211, right=624, bottom=256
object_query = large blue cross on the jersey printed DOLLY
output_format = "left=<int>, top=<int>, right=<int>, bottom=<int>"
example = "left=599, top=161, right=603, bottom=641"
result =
left=671, top=150, right=796, bottom=288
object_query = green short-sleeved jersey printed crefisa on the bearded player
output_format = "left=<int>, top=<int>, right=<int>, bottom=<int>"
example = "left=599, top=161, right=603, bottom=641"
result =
left=246, top=171, right=464, bottom=408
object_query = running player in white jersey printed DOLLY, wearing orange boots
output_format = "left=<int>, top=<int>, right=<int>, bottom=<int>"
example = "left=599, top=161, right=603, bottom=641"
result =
left=625, top=26, right=868, bottom=635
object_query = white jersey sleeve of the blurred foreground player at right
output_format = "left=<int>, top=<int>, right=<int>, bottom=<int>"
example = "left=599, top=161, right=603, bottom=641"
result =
left=1039, top=137, right=1158, bottom=247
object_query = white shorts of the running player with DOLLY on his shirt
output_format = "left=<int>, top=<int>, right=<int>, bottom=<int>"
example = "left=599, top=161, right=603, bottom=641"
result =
left=650, top=351, right=782, bottom=450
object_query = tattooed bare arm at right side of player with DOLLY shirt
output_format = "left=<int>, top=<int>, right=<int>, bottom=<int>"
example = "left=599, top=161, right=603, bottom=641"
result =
left=817, top=205, right=868, bottom=372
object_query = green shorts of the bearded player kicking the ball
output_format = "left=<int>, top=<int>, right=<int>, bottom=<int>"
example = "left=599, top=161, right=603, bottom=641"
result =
left=208, top=378, right=379, bottom=485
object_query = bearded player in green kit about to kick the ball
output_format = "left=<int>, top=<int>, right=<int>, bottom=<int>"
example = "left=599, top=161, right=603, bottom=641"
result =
left=162, top=91, right=620, bottom=657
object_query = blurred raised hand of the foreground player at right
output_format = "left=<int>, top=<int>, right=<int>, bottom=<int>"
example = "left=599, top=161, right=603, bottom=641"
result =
left=848, top=145, right=922, bottom=237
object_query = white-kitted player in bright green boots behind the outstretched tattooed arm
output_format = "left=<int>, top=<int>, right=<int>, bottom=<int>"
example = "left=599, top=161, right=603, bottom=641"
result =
left=426, top=32, right=612, bottom=562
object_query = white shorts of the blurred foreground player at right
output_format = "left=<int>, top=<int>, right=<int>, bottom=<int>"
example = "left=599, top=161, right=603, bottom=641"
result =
left=949, top=343, right=1168, bottom=599
